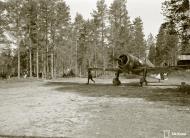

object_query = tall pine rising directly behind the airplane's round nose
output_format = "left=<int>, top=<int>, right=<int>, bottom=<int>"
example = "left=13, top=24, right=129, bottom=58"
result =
left=109, top=0, right=131, bottom=67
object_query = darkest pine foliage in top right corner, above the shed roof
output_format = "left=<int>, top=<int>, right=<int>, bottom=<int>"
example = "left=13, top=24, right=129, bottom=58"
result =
left=162, top=0, right=190, bottom=52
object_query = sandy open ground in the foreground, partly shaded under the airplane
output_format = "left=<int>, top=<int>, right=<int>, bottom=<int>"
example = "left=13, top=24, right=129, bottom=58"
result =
left=0, top=78, right=190, bottom=138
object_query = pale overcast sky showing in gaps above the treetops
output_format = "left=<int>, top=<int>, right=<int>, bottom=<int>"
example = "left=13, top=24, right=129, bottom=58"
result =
left=65, top=0, right=164, bottom=37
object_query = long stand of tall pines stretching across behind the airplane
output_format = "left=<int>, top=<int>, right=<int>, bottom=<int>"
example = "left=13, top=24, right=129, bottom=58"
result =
left=0, top=0, right=189, bottom=78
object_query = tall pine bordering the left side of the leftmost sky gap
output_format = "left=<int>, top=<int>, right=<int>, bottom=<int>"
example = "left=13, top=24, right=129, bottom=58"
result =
left=50, top=1, right=72, bottom=78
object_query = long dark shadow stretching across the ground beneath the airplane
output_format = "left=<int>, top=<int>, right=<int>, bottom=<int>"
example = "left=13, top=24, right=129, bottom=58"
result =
left=45, top=82, right=190, bottom=106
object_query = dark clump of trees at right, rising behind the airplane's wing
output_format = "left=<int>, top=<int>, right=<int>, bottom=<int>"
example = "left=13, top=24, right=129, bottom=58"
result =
left=148, top=0, right=190, bottom=65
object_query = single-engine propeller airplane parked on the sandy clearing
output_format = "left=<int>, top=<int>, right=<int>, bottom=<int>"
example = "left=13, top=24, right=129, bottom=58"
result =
left=88, top=54, right=190, bottom=86
